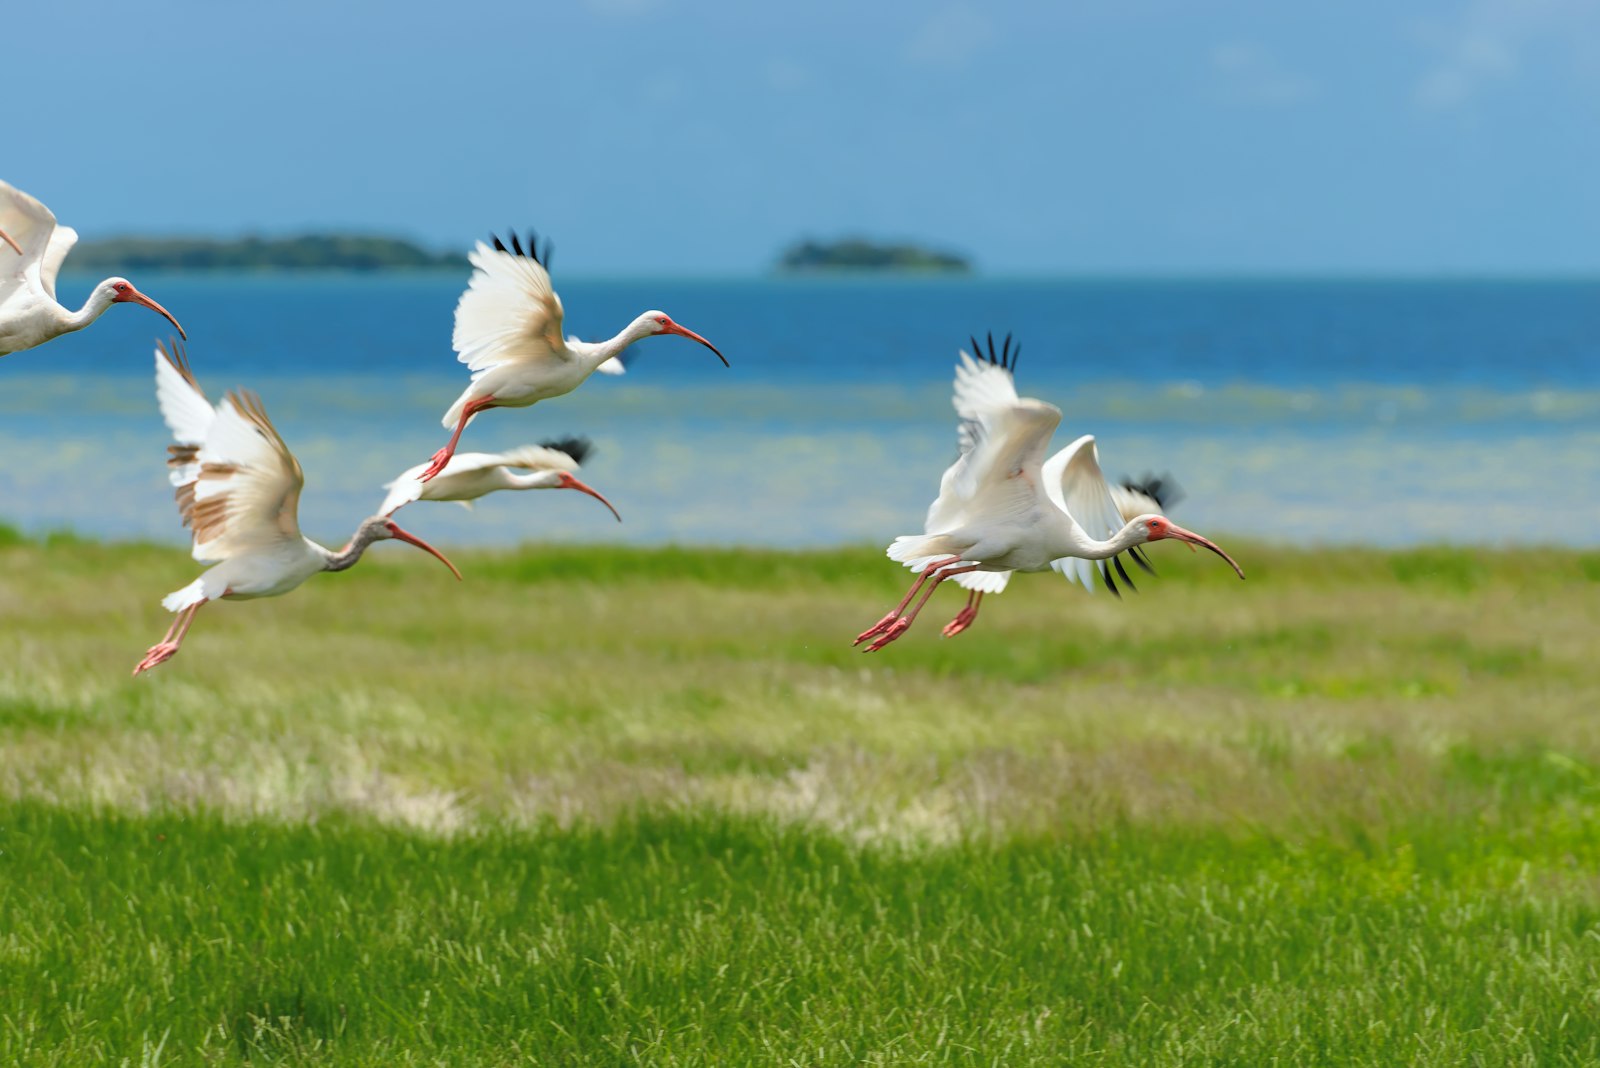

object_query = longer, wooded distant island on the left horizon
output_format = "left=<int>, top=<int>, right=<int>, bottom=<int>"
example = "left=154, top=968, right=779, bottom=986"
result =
left=67, top=233, right=467, bottom=273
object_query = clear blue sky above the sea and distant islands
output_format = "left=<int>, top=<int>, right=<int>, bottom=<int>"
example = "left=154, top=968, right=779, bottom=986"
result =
left=12, top=0, right=1600, bottom=275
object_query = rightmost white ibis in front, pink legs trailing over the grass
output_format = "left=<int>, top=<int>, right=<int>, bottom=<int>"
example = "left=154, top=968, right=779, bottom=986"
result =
left=856, top=330, right=1245, bottom=652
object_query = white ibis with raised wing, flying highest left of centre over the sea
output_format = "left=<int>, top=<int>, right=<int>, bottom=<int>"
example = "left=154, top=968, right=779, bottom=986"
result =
left=418, top=233, right=728, bottom=483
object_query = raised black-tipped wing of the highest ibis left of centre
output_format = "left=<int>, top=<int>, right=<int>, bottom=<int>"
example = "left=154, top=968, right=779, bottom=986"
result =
left=451, top=233, right=570, bottom=379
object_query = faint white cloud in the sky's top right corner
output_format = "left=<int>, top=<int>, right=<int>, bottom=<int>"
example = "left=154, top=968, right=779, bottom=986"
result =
left=1411, top=0, right=1600, bottom=112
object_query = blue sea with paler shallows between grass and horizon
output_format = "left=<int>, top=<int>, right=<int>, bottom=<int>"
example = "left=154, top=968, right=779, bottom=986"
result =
left=0, top=275, right=1600, bottom=547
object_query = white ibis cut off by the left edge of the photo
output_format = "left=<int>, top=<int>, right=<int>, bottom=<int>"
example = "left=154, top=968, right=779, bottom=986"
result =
left=0, top=182, right=187, bottom=357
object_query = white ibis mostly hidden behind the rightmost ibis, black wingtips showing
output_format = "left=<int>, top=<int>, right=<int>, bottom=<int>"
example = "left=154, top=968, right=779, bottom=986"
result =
left=923, top=334, right=1182, bottom=638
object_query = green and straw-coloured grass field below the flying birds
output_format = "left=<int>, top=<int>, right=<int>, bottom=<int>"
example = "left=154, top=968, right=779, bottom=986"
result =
left=0, top=537, right=1600, bottom=1066
